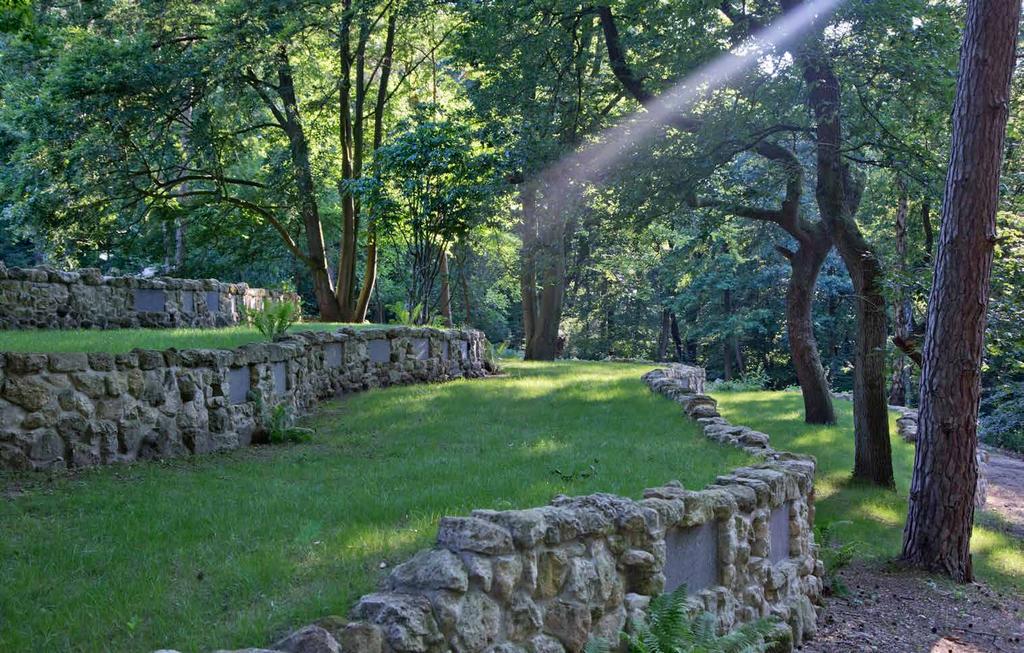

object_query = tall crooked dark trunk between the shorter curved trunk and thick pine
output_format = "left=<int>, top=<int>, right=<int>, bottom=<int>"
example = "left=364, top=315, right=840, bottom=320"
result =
left=781, top=0, right=895, bottom=487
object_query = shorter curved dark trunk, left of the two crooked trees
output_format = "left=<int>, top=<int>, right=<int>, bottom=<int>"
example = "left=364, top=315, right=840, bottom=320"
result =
left=785, top=223, right=836, bottom=424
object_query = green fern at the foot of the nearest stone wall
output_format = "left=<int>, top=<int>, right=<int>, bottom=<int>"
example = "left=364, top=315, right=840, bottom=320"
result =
left=586, top=585, right=778, bottom=653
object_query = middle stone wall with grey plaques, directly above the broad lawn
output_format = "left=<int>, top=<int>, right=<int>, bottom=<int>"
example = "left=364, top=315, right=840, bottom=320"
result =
left=0, top=328, right=484, bottom=470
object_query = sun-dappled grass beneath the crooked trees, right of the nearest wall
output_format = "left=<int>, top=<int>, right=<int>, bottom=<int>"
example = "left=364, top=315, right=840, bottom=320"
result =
left=714, top=392, right=1024, bottom=591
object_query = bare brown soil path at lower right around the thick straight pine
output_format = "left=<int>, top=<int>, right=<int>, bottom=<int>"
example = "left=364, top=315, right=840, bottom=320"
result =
left=800, top=450, right=1024, bottom=653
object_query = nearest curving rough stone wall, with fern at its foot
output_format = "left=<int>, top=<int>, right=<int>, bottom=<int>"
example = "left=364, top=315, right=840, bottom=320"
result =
left=188, top=365, right=823, bottom=653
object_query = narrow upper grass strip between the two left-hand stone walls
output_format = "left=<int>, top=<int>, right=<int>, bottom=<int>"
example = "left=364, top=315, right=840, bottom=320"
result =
left=0, top=322, right=392, bottom=353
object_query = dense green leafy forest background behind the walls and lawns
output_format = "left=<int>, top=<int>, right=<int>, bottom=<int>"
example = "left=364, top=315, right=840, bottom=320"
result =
left=0, top=0, right=1024, bottom=448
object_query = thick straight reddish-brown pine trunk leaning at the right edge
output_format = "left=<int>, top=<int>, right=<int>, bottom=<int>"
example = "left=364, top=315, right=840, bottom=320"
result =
left=903, top=0, right=1021, bottom=582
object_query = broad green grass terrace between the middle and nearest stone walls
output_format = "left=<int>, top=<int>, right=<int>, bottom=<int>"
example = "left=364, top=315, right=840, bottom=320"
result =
left=0, top=362, right=751, bottom=653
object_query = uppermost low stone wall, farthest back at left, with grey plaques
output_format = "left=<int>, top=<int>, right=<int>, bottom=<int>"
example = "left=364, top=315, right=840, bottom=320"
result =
left=0, top=262, right=294, bottom=329
